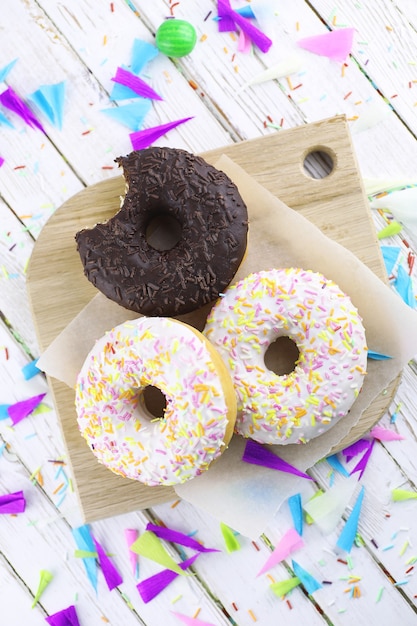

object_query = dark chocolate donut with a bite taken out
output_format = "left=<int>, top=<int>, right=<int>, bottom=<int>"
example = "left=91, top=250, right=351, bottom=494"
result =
left=75, top=147, right=248, bottom=316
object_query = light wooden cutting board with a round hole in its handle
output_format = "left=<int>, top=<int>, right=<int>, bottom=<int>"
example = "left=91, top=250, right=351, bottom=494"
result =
left=27, top=116, right=398, bottom=521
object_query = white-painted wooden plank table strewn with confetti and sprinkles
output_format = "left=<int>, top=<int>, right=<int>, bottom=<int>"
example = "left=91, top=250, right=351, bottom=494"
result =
left=0, top=0, right=417, bottom=626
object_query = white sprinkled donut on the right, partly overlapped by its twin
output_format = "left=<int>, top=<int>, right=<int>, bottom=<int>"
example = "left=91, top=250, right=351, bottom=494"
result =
left=203, top=268, right=367, bottom=444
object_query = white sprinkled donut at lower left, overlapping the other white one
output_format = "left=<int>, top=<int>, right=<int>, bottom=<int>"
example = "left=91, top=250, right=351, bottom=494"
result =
left=76, top=317, right=236, bottom=485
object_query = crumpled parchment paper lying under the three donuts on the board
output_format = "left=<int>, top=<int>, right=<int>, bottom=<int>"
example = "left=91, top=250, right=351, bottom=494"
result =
left=38, top=156, right=417, bottom=538
